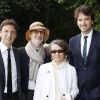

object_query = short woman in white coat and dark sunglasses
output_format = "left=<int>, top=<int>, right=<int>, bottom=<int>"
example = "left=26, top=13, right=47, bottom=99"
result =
left=33, top=39, right=79, bottom=100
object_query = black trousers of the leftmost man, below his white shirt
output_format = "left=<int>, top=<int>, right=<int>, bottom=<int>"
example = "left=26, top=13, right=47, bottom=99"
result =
left=3, top=92, right=19, bottom=100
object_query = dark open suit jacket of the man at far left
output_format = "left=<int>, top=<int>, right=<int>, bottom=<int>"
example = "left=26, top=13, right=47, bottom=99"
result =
left=0, top=48, right=22, bottom=100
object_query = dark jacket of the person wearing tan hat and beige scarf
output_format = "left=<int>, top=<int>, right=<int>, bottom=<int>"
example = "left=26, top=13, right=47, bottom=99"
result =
left=19, top=47, right=50, bottom=95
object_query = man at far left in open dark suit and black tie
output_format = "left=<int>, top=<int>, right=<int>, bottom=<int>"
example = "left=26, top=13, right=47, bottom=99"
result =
left=0, top=19, right=22, bottom=100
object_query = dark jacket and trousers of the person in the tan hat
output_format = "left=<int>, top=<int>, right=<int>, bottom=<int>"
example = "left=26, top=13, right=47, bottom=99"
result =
left=19, top=47, right=50, bottom=100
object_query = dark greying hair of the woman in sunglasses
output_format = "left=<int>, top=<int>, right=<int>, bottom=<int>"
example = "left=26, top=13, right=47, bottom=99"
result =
left=49, top=39, right=69, bottom=59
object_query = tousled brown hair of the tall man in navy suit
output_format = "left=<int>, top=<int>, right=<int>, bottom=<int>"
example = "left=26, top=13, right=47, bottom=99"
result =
left=74, top=4, right=94, bottom=20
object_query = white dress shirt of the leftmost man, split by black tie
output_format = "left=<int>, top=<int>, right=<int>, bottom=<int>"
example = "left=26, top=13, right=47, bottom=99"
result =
left=0, top=41, right=17, bottom=93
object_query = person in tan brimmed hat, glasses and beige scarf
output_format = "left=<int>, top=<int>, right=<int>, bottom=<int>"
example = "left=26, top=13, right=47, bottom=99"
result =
left=19, top=22, right=49, bottom=100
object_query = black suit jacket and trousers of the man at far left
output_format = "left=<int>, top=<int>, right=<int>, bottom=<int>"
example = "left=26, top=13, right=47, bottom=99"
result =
left=0, top=48, right=22, bottom=100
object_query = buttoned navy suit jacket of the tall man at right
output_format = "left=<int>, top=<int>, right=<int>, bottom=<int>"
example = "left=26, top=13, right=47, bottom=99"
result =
left=69, top=31, right=100, bottom=100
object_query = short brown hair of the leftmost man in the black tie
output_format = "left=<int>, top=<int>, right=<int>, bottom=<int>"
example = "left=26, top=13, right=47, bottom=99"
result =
left=0, top=19, right=18, bottom=31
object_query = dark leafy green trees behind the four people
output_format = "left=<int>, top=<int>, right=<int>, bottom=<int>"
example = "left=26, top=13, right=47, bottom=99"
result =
left=0, top=0, right=100, bottom=47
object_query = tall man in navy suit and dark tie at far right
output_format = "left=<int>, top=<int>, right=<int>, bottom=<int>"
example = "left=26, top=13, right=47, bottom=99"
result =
left=69, top=5, right=100, bottom=100
